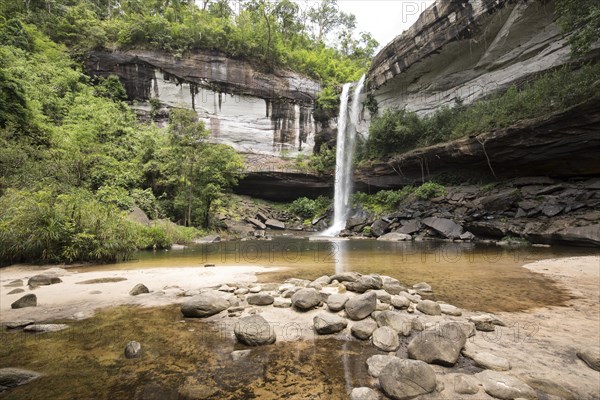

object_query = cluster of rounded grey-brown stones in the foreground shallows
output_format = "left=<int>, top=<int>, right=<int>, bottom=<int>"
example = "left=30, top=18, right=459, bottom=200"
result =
left=181, top=272, right=598, bottom=400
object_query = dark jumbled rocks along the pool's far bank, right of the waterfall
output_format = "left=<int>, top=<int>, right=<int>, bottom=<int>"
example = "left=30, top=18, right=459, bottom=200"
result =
left=342, top=177, right=600, bottom=246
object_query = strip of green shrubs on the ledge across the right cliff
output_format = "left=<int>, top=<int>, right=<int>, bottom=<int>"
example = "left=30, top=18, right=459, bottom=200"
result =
left=359, top=64, right=600, bottom=159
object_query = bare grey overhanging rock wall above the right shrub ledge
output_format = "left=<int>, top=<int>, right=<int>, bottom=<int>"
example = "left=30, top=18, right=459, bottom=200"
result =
left=367, top=0, right=598, bottom=114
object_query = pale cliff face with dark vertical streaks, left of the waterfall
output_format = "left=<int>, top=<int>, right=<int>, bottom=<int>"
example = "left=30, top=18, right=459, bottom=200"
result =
left=86, top=50, right=320, bottom=154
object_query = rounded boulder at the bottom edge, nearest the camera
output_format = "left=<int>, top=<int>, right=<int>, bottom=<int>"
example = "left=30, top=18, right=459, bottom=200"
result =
left=379, top=359, right=436, bottom=400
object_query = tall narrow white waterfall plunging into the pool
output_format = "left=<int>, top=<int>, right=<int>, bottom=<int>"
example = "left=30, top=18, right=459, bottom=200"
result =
left=323, top=75, right=365, bottom=236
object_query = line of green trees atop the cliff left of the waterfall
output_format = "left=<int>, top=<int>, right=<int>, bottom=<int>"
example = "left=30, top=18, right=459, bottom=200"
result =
left=0, top=0, right=378, bottom=115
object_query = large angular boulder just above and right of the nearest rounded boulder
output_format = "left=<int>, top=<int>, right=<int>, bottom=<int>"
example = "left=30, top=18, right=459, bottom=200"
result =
left=408, top=324, right=467, bottom=366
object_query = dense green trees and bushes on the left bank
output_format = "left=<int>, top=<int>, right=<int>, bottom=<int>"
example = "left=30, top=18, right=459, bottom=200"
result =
left=0, top=20, right=242, bottom=263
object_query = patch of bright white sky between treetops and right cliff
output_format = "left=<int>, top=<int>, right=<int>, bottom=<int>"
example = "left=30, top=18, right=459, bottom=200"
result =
left=338, top=0, right=433, bottom=48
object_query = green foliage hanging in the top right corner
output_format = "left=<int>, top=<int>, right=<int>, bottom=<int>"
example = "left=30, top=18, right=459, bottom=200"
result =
left=556, top=0, right=600, bottom=56
